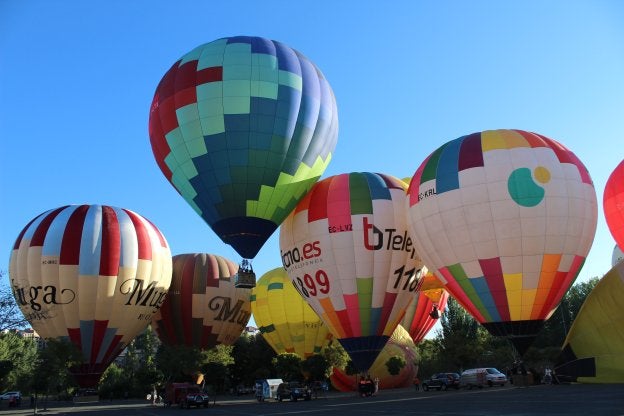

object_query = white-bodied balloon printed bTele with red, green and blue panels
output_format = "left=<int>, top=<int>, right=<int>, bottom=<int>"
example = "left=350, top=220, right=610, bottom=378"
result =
left=280, top=172, right=423, bottom=372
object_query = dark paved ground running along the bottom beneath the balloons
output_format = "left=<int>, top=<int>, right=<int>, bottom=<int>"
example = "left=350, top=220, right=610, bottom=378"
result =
left=0, top=384, right=624, bottom=416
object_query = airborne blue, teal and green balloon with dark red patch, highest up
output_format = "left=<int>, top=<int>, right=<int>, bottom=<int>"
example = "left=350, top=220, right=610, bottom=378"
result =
left=149, top=36, right=338, bottom=259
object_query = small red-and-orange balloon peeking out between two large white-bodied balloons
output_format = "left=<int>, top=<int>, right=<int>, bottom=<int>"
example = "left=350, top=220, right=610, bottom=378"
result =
left=401, top=272, right=449, bottom=344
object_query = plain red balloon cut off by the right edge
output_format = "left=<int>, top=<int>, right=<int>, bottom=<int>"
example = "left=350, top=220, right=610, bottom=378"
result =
left=602, top=160, right=624, bottom=250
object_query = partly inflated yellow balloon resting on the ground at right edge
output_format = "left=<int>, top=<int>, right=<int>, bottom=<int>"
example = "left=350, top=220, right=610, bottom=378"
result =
left=555, top=262, right=624, bottom=383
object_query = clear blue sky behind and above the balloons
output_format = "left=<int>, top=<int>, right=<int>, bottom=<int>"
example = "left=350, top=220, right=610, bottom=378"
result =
left=0, top=0, right=624, bottom=332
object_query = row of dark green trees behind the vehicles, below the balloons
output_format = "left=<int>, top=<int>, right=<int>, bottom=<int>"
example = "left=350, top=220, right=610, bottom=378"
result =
left=0, top=278, right=598, bottom=398
